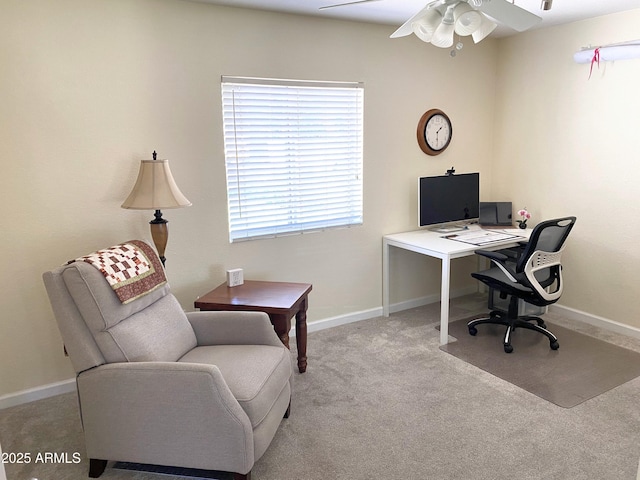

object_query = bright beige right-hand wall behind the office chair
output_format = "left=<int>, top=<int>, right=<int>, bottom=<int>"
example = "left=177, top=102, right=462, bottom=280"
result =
left=492, top=10, right=640, bottom=328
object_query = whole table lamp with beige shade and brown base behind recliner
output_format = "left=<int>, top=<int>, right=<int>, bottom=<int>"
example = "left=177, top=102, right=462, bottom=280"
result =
left=122, top=151, right=191, bottom=265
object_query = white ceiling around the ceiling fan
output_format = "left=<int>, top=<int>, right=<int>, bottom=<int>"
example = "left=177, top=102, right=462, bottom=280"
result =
left=189, top=0, right=640, bottom=37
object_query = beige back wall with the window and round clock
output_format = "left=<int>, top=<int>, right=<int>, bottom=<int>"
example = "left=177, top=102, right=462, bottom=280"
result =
left=0, top=0, right=497, bottom=398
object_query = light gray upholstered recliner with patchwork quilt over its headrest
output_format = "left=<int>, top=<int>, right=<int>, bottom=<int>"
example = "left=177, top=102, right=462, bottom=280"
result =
left=43, top=242, right=292, bottom=479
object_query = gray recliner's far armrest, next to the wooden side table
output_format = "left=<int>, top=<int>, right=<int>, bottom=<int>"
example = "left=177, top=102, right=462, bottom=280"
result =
left=187, top=311, right=282, bottom=347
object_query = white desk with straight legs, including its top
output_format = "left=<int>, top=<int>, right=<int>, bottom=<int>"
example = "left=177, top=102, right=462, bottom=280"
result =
left=382, top=225, right=531, bottom=345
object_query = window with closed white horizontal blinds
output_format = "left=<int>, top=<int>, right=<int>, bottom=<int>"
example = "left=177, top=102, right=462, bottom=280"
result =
left=222, top=77, right=364, bottom=242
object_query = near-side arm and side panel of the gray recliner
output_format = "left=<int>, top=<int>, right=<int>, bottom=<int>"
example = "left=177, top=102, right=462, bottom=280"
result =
left=77, top=362, right=254, bottom=472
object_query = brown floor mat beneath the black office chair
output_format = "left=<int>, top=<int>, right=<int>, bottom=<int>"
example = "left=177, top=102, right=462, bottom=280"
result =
left=440, top=317, right=640, bottom=408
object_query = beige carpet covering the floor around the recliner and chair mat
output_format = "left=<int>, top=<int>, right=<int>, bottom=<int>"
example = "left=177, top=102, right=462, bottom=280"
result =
left=0, top=295, right=640, bottom=480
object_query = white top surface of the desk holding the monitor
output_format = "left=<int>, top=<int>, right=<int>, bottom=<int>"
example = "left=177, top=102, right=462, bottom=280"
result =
left=383, top=225, right=531, bottom=258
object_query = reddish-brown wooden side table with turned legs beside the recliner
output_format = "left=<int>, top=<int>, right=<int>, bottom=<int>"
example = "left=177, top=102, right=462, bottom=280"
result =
left=194, top=280, right=313, bottom=373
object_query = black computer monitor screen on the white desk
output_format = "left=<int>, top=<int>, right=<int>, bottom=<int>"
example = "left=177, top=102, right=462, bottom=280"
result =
left=418, top=173, right=480, bottom=227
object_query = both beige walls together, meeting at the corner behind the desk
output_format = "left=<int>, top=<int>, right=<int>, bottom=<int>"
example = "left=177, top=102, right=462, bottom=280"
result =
left=0, top=0, right=640, bottom=398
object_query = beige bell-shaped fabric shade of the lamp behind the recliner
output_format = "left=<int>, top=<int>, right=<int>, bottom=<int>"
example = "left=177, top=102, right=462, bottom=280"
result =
left=122, top=160, right=191, bottom=210
